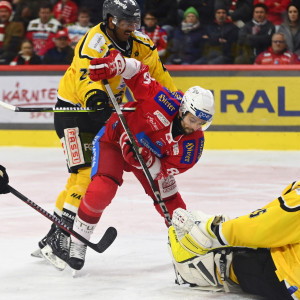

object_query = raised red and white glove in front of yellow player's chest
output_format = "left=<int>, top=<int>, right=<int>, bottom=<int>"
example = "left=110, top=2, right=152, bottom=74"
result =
left=90, top=50, right=126, bottom=81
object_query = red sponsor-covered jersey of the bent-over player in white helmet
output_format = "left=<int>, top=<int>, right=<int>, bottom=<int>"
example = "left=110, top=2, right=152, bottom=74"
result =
left=101, top=65, right=204, bottom=179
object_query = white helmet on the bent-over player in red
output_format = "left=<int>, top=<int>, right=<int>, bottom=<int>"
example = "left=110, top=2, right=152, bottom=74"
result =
left=179, top=86, right=215, bottom=130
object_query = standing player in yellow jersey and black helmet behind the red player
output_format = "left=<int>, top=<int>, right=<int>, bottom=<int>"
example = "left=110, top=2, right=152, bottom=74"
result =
left=32, top=0, right=177, bottom=269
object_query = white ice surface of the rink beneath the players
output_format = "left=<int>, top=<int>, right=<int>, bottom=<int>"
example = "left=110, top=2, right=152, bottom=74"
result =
left=0, top=147, right=300, bottom=300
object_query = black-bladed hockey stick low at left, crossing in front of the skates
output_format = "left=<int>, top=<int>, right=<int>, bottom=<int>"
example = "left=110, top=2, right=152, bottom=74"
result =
left=8, top=185, right=117, bottom=253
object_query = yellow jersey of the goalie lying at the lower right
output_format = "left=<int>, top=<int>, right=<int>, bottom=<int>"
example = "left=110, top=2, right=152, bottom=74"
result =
left=222, top=181, right=300, bottom=299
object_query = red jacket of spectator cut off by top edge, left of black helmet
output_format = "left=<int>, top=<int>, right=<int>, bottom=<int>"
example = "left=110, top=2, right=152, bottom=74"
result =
left=53, top=0, right=78, bottom=25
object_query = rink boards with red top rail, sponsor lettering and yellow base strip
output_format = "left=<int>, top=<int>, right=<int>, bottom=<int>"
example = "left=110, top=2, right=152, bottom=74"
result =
left=0, top=66, right=300, bottom=150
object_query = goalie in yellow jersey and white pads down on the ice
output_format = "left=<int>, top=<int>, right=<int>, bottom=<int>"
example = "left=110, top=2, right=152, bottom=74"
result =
left=169, top=181, right=300, bottom=300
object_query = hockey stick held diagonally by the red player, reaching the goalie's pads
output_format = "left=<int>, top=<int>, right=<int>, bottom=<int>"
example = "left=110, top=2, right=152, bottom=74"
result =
left=102, top=79, right=171, bottom=226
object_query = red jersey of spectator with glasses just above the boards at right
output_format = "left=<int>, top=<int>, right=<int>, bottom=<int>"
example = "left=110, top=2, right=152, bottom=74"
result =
left=255, top=47, right=300, bottom=65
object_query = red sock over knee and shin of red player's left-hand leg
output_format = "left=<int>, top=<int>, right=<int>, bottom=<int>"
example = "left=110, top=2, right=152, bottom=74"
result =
left=78, top=175, right=118, bottom=224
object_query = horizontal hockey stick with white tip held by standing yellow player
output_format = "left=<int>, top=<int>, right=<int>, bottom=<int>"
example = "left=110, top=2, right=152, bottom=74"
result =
left=0, top=101, right=134, bottom=113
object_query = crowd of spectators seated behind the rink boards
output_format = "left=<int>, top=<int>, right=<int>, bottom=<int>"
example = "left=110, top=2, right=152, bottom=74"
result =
left=0, top=0, right=300, bottom=65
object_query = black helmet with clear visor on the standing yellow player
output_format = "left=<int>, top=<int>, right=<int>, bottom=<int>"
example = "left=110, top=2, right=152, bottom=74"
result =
left=102, top=0, right=141, bottom=29
